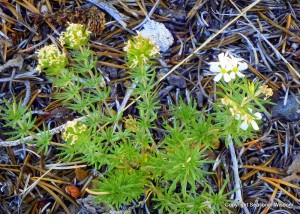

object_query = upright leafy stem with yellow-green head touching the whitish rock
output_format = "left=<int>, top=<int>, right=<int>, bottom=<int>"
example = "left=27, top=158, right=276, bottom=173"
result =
left=124, top=34, right=159, bottom=148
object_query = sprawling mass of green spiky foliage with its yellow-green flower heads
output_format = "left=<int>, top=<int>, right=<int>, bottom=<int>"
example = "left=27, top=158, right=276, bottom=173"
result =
left=0, top=25, right=268, bottom=213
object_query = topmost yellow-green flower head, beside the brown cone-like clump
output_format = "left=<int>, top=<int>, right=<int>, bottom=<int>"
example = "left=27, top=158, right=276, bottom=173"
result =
left=59, top=23, right=91, bottom=50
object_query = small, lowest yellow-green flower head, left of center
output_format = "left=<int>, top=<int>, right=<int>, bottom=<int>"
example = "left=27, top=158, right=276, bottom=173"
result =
left=62, top=121, right=87, bottom=145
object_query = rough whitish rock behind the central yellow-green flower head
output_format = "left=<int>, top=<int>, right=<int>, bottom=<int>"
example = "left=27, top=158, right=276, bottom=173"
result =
left=140, top=20, right=174, bottom=52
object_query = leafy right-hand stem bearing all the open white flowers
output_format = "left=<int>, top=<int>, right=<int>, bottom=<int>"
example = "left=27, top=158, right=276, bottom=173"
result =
left=210, top=53, right=273, bottom=144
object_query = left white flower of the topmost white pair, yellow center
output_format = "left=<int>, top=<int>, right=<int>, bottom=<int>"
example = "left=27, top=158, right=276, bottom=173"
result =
left=209, top=53, right=232, bottom=82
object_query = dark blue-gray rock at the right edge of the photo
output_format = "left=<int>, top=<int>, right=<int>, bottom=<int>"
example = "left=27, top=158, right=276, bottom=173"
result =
left=272, top=95, right=300, bottom=122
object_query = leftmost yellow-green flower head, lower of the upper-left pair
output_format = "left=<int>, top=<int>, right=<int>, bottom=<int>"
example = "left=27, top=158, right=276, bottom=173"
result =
left=37, top=45, right=68, bottom=71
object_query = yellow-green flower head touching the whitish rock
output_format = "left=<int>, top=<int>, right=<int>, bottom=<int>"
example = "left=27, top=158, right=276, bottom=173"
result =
left=124, top=33, right=159, bottom=68
